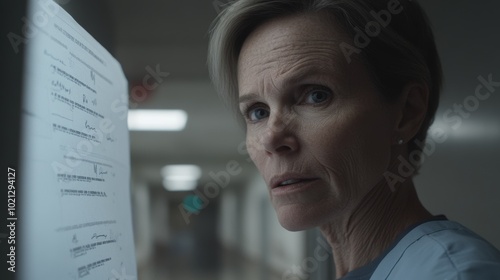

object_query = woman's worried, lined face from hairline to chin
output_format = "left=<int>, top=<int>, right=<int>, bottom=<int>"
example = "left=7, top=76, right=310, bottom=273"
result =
left=238, top=14, right=402, bottom=230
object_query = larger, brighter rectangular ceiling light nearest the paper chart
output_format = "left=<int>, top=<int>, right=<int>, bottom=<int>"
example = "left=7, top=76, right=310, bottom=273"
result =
left=128, top=110, right=187, bottom=131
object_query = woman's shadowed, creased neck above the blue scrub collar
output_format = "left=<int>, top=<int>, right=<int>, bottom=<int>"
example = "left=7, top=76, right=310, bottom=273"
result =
left=320, top=179, right=432, bottom=278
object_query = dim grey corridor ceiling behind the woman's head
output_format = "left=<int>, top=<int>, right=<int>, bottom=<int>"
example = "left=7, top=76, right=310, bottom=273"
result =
left=61, top=0, right=500, bottom=189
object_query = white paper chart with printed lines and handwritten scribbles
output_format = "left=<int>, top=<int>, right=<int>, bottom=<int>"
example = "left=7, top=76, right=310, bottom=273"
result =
left=17, top=0, right=137, bottom=280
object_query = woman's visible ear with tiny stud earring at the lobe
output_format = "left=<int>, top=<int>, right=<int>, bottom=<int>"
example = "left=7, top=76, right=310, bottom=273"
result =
left=394, top=83, right=429, bottom=143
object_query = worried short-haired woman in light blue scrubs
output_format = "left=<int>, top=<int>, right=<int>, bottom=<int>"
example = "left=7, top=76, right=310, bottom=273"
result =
left=209, top=0, right=500, bottom=280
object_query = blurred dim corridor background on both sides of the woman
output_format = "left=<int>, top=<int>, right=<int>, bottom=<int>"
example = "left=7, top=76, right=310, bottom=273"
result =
left=59, top=0, right=500, bottom=280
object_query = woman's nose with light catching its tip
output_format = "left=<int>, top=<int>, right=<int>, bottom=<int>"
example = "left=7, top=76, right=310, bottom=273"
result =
left=259, top=117, right=299, bottom=155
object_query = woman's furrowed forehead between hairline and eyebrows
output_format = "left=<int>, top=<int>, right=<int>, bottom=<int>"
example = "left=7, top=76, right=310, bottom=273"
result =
left=240, top=18, right=343, bottom=96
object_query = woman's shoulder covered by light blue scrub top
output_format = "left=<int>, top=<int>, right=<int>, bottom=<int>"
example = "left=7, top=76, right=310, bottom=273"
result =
left=372, top=221, right=500, bottom=280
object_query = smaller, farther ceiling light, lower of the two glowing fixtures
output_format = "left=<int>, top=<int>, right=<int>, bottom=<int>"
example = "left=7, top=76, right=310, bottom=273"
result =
left=161, top=164, right=201, bottom=191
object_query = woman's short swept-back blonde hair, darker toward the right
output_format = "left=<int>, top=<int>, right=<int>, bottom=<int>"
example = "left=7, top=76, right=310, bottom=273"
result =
left=208, top=0, right=442, bottom=160
